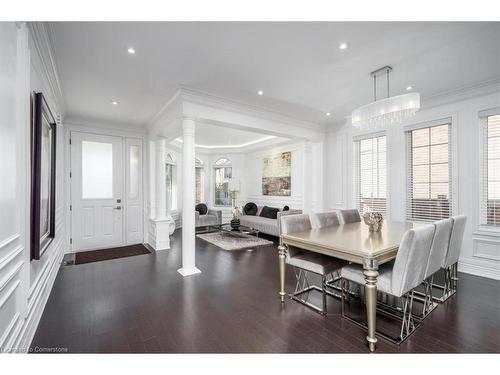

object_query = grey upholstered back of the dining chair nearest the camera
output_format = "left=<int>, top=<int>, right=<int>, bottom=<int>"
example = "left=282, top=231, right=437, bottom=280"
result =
left=391, top=224, right=435, bottom=297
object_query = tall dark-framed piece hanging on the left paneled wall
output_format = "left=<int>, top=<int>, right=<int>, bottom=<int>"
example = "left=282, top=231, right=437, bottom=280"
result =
left=30, top=92, right=57, bottom=260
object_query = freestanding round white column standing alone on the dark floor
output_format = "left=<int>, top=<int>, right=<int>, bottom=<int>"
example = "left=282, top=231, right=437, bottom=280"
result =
left=178, top=118, right=201, bottom=276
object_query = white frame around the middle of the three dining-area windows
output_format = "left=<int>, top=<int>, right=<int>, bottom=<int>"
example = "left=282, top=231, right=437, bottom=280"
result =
left=404, top=116, right=458, bottom=222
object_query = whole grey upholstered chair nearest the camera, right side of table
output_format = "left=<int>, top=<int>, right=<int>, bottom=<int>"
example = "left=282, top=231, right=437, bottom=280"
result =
left=341, top=224, right=435, bottom=343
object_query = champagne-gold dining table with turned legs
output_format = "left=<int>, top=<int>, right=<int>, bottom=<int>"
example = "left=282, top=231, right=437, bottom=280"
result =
left=278, top=221, right=416, bottom=352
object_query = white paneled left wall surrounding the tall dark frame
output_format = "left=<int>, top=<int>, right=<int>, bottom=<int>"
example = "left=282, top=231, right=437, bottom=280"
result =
left=0, top=23, right=66, bottom=351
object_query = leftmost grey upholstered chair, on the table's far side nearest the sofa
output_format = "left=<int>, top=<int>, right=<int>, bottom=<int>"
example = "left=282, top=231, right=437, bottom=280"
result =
left=280, top=214, right=346, bottom=315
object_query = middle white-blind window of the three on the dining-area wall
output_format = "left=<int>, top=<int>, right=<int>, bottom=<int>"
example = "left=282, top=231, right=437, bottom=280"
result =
left=406, top=122, right=452, bottom=221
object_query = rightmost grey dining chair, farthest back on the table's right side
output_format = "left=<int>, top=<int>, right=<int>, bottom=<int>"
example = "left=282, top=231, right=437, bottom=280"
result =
left=432, top=215, right=467, bottom=302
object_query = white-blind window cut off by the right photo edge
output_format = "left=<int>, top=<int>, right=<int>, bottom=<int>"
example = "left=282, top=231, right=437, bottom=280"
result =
left=480, top=113, right=500, bottom=226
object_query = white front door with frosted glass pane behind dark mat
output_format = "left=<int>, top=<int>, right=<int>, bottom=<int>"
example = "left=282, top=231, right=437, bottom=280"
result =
left=71, top=132, right=125, bottom=251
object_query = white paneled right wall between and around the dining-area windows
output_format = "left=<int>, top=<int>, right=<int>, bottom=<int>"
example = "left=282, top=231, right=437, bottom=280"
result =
left=326, top=92, right=500, bottom=279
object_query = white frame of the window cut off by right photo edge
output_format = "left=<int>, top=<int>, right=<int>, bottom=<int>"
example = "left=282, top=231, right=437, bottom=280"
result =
left=478, top=107, right=500, bottom=231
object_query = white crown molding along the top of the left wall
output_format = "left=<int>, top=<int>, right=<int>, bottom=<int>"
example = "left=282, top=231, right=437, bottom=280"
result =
left=27, top=22, right=66, bottom=117
